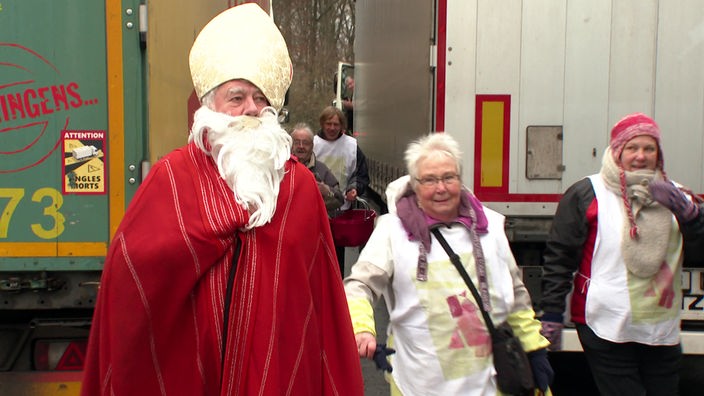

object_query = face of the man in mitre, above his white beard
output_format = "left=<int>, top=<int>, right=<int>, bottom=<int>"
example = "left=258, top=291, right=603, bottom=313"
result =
left=213, top=80, right=269, bottom=117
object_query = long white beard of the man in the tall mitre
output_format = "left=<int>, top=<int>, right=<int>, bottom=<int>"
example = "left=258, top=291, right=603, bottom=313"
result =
left=188, top=106, right=291, bottom=229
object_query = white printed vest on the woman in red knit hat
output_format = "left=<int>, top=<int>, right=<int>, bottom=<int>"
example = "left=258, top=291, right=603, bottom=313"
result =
left=585, top=175, right=683, bottom=345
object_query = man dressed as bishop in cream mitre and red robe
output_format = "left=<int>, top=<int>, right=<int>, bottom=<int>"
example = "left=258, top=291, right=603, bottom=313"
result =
left=81, top=3, right=364, bottom=396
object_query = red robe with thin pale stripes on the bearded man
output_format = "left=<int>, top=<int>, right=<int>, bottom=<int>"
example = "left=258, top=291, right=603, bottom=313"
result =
left=82, top=144, right=364, bottom=396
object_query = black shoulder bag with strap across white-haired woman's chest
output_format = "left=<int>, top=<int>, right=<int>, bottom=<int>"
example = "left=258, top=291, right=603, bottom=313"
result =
left=432, top=228, right=535, bottom=395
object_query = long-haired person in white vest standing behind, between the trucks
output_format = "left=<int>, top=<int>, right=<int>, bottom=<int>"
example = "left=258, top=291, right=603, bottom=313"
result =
left=313, top=106, right=369, bottom=276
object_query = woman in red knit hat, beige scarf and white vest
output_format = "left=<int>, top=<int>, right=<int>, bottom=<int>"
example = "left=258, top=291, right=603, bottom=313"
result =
left=541, top=113, right=704, bottom=396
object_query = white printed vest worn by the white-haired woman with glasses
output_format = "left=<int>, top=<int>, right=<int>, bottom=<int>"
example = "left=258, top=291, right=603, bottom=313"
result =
left=359, top=212, right=518, bottom=396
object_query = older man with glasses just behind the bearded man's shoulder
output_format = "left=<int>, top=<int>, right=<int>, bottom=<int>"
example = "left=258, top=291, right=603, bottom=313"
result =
left=291, top=122, right=345, bottom=214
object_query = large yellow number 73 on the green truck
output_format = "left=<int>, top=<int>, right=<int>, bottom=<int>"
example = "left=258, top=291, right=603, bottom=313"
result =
left=0, top=187, right=66, bottom=239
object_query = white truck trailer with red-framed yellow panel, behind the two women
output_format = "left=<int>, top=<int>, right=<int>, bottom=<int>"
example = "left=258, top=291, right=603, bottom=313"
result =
left=352, top=0, right=704, bottom=394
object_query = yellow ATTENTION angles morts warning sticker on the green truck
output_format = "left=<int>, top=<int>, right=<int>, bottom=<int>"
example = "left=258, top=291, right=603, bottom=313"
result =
left=62, top=131, right=106, bottom=194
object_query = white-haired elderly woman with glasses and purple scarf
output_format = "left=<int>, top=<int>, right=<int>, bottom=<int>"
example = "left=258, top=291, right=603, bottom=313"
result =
left=345, top=133, right=553, bottom=396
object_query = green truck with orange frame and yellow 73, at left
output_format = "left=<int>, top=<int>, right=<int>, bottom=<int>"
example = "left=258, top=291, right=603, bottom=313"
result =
left=0, top=0, right=241, bottom=395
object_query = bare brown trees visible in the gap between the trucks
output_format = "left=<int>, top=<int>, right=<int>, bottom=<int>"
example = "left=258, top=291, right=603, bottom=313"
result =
left=274, top=0, right=355, bottom=130
